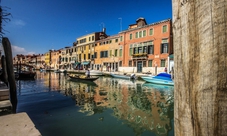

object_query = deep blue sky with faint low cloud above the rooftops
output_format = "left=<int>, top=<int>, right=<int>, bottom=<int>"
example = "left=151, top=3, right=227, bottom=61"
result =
left=0, top=0, right=172, bottom=55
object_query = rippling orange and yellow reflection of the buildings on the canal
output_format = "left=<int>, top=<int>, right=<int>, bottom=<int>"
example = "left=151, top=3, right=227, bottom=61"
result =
left=17, top=72, right=174, bottom=136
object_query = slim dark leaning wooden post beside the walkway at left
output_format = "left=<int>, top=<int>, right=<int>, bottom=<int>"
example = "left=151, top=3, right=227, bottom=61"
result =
left=2, top=37, right=17, bottom=113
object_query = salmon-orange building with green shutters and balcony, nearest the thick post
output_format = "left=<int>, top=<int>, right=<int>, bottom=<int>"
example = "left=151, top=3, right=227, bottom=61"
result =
left=119, top=18, right=173, bottom=74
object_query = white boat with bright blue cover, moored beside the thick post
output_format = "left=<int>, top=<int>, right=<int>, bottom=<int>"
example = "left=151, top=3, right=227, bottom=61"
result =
left=141, top=73, right=174, bottom=86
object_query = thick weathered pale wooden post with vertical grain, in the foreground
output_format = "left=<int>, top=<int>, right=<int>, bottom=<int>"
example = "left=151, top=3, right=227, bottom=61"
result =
left=172, top=0, right=227, bottom=136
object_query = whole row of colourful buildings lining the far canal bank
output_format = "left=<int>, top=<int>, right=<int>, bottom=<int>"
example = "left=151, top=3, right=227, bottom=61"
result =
left=13, top=18, right=173, bottom=73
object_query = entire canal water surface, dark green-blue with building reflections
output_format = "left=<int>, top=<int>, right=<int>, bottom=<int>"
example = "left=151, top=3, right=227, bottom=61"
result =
left=17, top=72, right=174, bottom=136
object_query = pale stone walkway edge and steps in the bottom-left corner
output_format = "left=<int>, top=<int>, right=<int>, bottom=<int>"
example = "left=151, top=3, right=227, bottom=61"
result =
left=0, top=83, right=41, bottom=136
